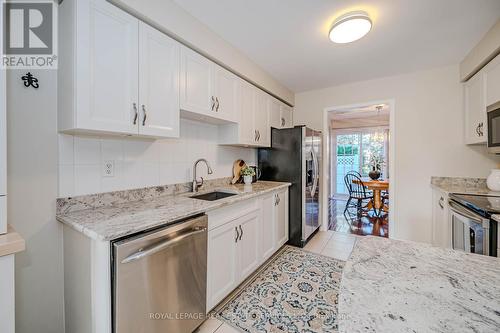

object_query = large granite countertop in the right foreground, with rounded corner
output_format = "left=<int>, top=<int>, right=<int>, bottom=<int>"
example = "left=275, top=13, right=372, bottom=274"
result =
left=339, top=237, right=500, bottom=333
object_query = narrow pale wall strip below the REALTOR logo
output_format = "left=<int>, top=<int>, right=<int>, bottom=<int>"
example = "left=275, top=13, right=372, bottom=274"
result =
left=7, top=70, right=64, bottom=333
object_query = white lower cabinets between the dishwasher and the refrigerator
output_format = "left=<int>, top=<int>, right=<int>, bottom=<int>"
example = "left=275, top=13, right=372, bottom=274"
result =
left=207, top=190, right=288, bottom=311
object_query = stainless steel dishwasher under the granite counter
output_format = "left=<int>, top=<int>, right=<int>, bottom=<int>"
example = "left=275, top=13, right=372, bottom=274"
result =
left=112, top=215, right=208, bottom=333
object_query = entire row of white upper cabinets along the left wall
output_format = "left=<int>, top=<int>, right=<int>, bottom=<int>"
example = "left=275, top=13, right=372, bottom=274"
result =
left=58, top=0, right=291, bottom=141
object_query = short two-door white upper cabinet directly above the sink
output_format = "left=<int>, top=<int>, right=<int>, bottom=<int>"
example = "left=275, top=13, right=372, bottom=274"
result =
left=181, top=47, right=239, bottom=123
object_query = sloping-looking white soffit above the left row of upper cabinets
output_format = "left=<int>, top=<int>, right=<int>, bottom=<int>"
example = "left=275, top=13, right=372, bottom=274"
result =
left=110, top=0, right=294, bottom=105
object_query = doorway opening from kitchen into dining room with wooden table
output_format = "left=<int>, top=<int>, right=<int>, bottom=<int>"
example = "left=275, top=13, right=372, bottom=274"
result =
left=327, top=103, right=391, bottom=237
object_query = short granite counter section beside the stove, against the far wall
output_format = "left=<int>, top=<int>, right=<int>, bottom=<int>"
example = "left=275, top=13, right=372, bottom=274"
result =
left=431, top=177, right=500, bottom=197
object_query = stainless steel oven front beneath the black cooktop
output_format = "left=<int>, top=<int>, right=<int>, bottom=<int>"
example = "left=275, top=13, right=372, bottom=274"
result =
left=449, top=200, right=490, bottom=256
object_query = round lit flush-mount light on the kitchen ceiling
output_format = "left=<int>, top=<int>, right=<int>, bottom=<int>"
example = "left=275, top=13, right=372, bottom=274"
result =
left=329, top=11, right=372, bottom=44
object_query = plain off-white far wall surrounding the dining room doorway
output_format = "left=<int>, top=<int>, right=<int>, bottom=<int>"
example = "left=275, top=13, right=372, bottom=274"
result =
left=294, top=65, right=499, bottom=242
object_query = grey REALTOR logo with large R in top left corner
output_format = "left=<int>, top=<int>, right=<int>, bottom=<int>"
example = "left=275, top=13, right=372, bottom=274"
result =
left=1, top=0, right=57, bottom=69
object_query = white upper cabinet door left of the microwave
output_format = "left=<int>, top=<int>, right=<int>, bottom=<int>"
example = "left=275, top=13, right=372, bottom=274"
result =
left=464, top=71, right=486, bottom=144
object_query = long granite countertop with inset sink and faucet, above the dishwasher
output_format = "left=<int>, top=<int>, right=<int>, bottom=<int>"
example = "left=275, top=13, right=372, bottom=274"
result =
left=57, top=181, right=291, bottom=241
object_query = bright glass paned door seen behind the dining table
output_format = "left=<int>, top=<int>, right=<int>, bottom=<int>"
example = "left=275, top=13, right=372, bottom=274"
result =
left=332, top=128, right=389, bottom=196
